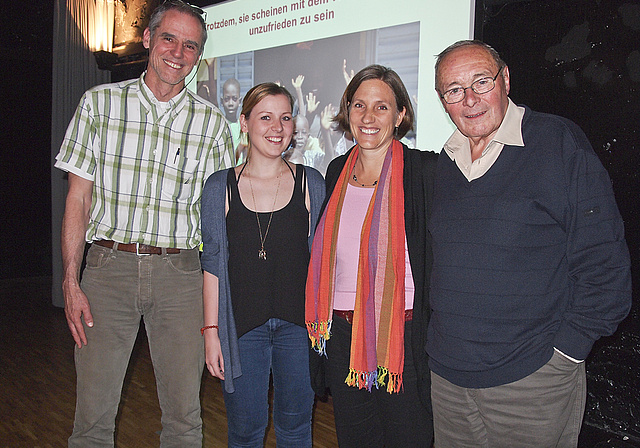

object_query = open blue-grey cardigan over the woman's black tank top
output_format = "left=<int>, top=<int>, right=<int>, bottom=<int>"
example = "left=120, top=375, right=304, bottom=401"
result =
left=201, top=165, right=325, bottom=393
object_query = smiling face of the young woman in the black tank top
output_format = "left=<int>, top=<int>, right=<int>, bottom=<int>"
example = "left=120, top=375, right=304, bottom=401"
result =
left=240, top=95, right=293, bottom=158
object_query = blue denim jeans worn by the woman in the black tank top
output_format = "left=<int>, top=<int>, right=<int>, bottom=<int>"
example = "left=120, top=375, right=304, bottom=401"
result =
left=223, top=318, right=314, bottom=448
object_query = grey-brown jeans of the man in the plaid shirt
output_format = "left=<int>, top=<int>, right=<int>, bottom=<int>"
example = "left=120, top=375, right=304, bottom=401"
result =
left=69, top=244, right=204, bottom=448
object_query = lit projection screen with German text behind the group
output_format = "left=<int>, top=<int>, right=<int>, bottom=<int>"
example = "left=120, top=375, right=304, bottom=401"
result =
left=189, top=0, right=475, bottom=161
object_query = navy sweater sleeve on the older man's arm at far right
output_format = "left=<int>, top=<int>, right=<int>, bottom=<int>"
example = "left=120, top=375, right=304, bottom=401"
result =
left=554, top=121, right=631, bottom=359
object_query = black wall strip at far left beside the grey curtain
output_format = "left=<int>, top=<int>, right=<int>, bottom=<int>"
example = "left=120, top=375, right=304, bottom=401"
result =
left=0, top=1, right=53, bottom=279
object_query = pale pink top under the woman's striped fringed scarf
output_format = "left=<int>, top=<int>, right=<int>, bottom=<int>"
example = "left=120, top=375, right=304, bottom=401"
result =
left=333, top=184, right=414, bottom=310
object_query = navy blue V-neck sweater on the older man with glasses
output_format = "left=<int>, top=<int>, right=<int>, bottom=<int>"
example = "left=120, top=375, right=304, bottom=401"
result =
left=427, top=108, right=631, bottom=388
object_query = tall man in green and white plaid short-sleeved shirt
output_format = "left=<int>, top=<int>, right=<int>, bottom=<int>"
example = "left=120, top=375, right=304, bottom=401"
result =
left=55, top=0, right=233, bottom=447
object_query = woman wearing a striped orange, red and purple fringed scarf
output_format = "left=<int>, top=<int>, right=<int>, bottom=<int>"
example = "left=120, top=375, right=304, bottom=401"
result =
left=306, top=65, right=437, bottom=448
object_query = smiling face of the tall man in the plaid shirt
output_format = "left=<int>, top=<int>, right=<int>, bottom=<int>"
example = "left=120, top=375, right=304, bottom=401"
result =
left=142, top=10, right=202, bottom=101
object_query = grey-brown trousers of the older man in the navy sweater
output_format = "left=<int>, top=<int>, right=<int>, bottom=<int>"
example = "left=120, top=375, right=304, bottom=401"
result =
left=431, top=352, right=587, bottom=448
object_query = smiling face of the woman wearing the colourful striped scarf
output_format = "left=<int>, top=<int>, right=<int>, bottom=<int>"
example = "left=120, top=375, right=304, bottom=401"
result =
left=349, top=79, right=405, bottom=151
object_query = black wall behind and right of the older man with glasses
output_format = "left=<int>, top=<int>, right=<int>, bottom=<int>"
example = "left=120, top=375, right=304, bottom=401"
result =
left=476, top=0, right=640, bottom=440
